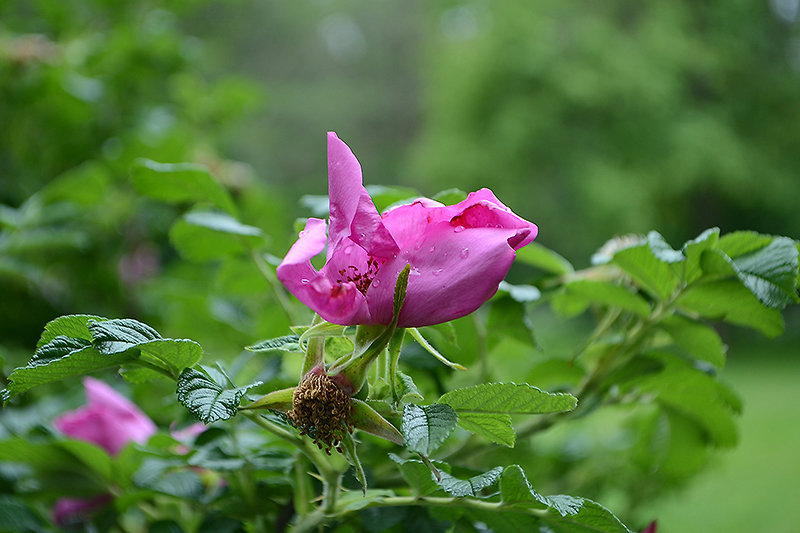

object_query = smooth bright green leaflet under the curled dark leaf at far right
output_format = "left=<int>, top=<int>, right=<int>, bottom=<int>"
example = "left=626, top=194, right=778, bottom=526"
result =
left=678, top=280, right=784, bottom=337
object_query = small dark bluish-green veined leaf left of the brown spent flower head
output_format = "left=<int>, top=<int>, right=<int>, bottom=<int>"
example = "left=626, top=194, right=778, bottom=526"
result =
left=176, top=367, right=261, bottom=424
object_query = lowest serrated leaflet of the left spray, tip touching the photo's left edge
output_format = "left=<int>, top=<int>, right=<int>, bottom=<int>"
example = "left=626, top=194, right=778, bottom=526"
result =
left=2, top=346, right=136, bottom=402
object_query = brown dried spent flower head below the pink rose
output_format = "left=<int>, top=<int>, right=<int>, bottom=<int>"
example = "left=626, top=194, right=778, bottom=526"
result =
left=287, top=373, right=353, bottom=455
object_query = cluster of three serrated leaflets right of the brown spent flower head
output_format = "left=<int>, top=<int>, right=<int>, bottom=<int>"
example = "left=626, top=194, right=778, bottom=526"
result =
left=402, top=383, right=577, bottom=455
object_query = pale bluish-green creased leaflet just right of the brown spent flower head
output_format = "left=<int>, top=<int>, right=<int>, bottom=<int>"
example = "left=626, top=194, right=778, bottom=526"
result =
left=402, top=404, right=458, bottom=456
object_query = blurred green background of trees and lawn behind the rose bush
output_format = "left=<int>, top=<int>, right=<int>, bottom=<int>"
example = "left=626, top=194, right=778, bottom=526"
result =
left=0, top=0, right=800, bottom=533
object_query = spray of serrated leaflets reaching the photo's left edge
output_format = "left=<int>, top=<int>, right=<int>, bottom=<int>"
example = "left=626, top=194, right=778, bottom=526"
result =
left=3, top=315, right=203, bottom=401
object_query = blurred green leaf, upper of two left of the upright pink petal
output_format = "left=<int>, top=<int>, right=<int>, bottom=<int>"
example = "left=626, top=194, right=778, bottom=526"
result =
left=132, top=159, right=236, bottom=213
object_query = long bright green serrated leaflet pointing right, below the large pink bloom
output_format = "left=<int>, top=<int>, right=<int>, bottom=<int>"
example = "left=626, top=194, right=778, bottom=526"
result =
left=437, top=383, right=578, bottom=415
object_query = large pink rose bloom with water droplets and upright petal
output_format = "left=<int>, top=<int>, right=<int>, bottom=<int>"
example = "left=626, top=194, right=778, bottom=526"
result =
left=278, top=132, right=538, bottom=327
